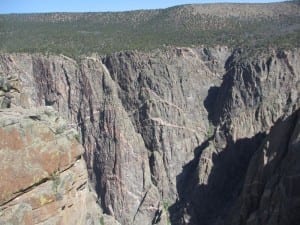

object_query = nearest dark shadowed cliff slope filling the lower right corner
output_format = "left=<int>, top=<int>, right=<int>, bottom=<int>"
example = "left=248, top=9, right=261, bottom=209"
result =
left=227, top=110, right=300, bottom=225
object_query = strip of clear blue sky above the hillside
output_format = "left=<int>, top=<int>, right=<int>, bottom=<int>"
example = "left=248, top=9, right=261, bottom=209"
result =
left=0, top=0, right=282, bottom=14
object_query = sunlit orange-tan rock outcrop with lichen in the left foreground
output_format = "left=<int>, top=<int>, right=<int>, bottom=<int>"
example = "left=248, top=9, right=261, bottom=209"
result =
left=0, top=107, right=117, bottom=225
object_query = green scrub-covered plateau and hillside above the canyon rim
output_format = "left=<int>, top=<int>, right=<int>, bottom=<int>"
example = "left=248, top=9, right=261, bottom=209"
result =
left=0, top=1, right=300, bottom=56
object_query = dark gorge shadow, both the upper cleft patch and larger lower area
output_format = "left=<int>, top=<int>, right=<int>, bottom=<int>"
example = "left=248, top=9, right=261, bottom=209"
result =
left=169, top=50, right=266, bottom=225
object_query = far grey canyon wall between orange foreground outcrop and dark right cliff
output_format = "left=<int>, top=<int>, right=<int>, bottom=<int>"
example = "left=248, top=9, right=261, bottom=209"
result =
left=0, top=47, right=300, bottom=224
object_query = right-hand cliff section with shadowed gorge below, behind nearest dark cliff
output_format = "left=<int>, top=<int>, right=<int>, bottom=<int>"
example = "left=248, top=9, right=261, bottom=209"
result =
left=173, top=50, right=300, bottom=224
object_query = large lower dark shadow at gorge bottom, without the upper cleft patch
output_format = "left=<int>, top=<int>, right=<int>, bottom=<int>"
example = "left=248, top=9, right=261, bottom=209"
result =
left=169, top=133, right=266, bottom=225
